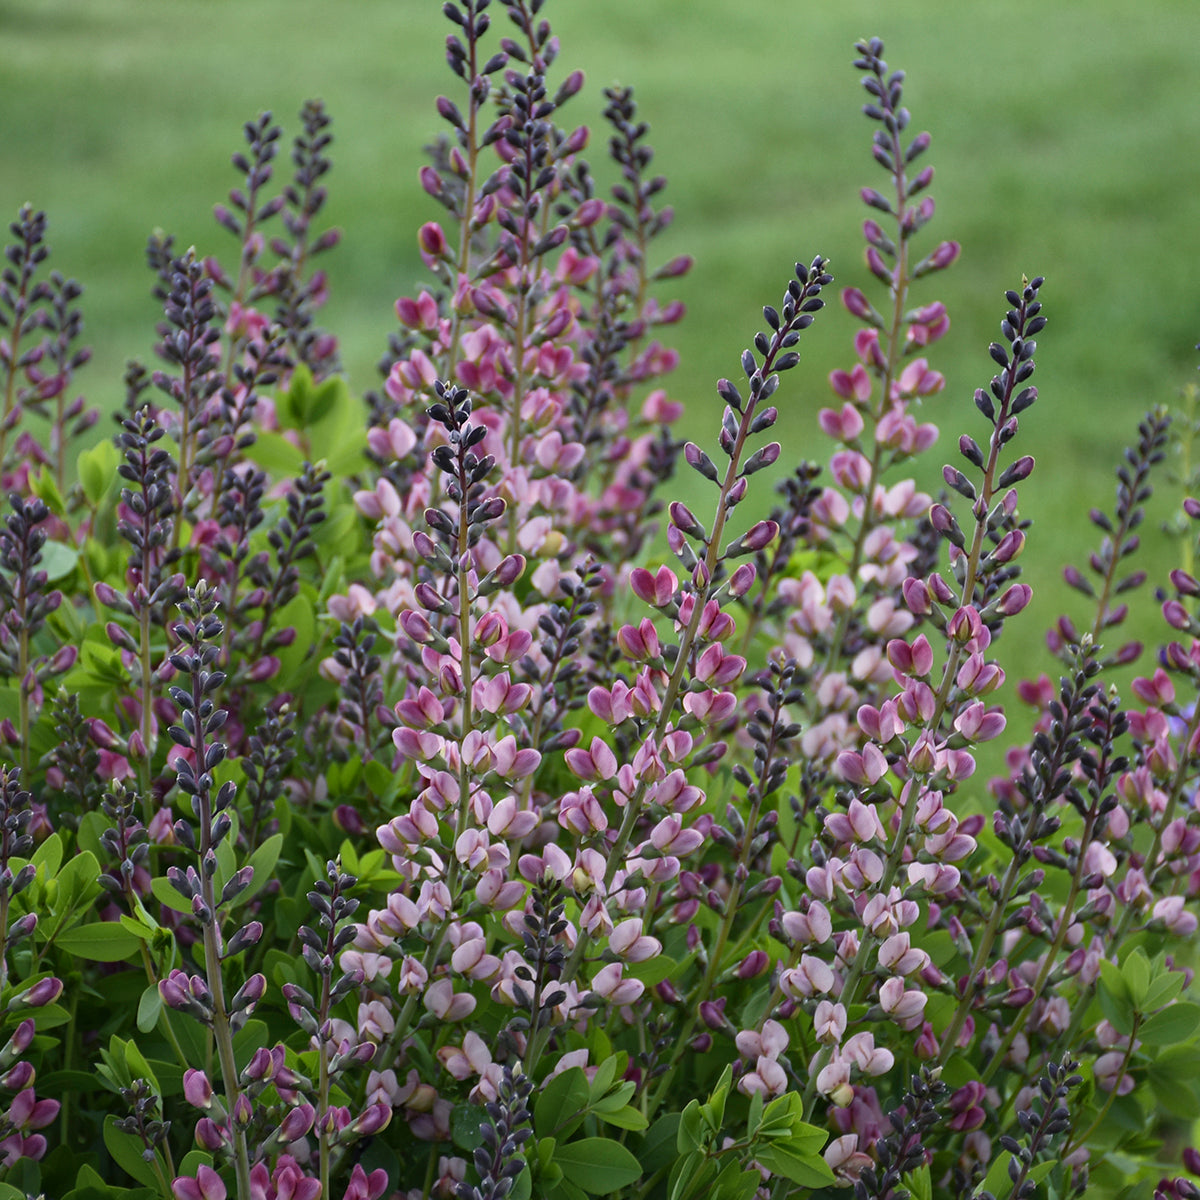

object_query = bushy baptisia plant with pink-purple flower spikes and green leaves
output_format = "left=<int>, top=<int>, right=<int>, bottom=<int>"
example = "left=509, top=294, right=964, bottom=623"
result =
left=0, top=7, right=1200, bottom=1200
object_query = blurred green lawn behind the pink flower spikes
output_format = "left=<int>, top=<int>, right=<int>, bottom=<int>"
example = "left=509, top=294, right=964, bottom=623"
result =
left=0, top=0, right=1200, bottom=670
